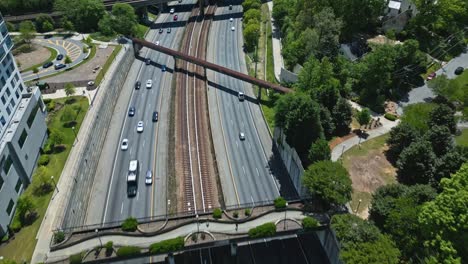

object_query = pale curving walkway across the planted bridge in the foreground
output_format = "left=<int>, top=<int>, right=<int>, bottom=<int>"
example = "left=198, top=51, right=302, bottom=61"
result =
left=44, top=211, right=305, bottom=261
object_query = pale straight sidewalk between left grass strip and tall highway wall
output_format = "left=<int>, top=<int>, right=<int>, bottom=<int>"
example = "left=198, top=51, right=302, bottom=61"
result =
left=31, top=42, right=129, bottom=263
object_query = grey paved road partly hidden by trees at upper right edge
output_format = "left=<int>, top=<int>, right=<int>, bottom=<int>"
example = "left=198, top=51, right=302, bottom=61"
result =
left=397, top=47, right=468, bottom=115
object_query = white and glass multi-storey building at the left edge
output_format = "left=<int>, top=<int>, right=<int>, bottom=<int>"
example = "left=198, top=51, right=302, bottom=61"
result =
left=0, top=14, right=47, bottom=235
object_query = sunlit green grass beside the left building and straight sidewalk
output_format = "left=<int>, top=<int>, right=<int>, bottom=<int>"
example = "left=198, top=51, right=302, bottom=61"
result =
left=0, top=96, right=89, bottom=263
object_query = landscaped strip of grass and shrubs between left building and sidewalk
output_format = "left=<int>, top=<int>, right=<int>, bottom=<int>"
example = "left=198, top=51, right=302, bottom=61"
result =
left=0, top=96, right=89, bottom=263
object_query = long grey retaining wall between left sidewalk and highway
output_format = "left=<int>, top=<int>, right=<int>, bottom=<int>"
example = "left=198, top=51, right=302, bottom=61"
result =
left=62, top=47, right=135, bottom=229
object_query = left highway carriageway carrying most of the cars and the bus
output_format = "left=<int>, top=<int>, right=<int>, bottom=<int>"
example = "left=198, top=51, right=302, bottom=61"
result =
left=86, top=2, right=194, bottom=224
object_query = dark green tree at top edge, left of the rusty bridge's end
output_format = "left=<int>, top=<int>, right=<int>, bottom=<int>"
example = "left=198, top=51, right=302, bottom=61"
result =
left=54, top=0, right=105, bottom=32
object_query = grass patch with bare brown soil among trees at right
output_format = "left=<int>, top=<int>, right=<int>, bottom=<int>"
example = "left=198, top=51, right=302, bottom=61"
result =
left=342, top=134, right=396, bottom=218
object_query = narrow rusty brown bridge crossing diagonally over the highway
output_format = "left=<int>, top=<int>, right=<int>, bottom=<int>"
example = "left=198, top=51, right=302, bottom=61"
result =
left=131, top=38, right=292, bottom=94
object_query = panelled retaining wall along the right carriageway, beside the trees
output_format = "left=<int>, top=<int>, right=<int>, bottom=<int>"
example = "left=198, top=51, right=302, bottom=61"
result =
left=273, top=127, right=308, bottom=196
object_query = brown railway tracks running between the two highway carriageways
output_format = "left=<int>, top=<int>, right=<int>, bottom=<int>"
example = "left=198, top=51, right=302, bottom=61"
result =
left=176, top=6, right=217, bottom=213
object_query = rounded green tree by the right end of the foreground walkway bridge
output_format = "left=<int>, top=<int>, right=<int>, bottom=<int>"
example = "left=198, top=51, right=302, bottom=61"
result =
left=303, top=160, right=352, bottom=209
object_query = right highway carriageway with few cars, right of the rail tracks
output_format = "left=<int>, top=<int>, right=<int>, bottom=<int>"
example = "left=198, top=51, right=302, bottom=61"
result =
left=208, top=3, right=286, bottom=206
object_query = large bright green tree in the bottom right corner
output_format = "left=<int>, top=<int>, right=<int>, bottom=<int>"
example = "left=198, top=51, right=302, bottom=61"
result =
left=418, top=163, right=468, bottom=263
